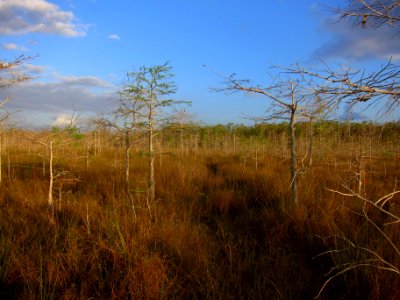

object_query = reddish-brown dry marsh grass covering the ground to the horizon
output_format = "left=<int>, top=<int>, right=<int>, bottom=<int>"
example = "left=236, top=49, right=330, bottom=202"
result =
left=0, top=122, right=400, bottom=299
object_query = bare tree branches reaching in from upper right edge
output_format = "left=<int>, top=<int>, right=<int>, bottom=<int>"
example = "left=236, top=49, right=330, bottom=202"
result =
left=286, top=0, right=400, bottom=114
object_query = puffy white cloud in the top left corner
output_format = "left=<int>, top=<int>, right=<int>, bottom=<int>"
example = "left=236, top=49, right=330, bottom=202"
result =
left=0, top=0, right=87, bottom=37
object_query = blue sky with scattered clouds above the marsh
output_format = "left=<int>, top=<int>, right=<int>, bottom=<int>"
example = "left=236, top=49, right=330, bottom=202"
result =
left=0, top=0, right=400, bottom=126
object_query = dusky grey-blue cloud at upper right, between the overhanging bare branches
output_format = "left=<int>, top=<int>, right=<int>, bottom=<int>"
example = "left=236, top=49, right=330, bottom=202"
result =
left=313, top=20, right=400, bottom=60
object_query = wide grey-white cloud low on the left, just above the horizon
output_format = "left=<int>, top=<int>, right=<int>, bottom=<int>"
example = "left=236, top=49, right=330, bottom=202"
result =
left=0, top=65, right=116, bottom=126
